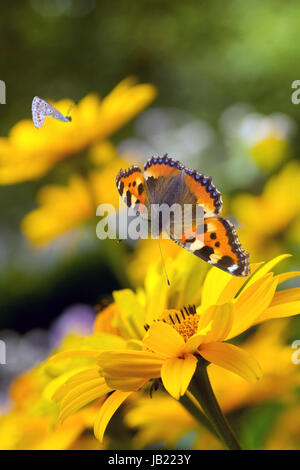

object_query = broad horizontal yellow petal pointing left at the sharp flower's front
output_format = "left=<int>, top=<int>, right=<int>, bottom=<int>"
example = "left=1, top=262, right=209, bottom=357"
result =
left=97, top=349, right=163, bottom=379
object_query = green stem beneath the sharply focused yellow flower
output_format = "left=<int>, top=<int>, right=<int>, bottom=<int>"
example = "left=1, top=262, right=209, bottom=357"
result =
left=189, top=359, right=241, bottom=450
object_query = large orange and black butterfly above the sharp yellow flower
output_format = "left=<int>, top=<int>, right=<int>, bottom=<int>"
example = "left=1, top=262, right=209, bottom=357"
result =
left=116, top=154, right=250, bottom=276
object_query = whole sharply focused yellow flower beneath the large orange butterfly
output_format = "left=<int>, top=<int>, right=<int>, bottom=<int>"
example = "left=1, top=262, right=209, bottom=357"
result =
left=51, top=252, right=300, bottom=441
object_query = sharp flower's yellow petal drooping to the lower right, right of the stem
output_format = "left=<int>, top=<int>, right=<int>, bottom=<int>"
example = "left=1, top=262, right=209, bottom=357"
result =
left=200, top=342, right=262, bottom=382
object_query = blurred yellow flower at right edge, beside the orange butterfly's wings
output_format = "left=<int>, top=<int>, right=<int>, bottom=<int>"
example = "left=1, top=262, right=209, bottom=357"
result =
left=231, top=161, right=300, bottom=259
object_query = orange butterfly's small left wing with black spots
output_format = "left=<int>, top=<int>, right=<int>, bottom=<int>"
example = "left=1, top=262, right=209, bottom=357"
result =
left=116, top=165, right=148, bottom=213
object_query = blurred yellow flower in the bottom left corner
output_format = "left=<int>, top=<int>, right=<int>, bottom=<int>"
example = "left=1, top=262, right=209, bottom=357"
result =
left=0, top=369, right=99, bottom=450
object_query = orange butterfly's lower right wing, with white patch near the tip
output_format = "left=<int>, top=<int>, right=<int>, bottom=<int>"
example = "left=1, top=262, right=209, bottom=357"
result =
left=171, top=217, right=250, bottom=276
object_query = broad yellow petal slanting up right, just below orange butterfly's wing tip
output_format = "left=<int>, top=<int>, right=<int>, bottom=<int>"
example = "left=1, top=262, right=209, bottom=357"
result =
left=227, top=273, right=277, bottom=339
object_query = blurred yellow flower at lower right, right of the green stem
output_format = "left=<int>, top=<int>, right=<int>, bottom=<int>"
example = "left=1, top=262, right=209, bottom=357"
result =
left=209, top=318, right=300, bottom=412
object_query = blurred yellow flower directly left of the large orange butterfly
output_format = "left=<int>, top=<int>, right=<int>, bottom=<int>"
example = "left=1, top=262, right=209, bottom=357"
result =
left=21, top=153, right=124, bottom=245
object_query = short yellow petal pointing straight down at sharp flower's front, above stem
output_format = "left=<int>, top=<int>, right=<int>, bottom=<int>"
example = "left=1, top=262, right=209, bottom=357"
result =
left=161, top=354, right=197, bottom=400
